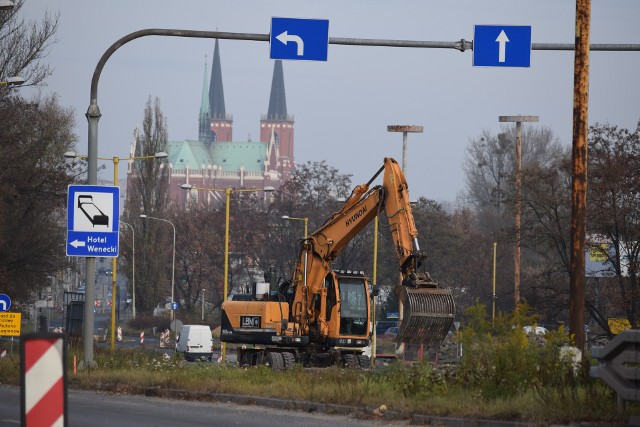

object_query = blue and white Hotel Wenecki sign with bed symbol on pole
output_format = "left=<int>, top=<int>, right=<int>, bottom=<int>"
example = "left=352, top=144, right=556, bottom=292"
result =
left=67, top=185, right=120, bottom=257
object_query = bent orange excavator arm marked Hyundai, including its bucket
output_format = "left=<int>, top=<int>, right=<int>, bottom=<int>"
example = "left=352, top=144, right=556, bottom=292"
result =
left=292, top=158, right=455, bottom=345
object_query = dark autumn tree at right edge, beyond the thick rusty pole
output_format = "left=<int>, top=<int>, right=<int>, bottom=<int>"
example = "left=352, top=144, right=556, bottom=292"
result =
left=587, top=122, right=640, bottom=330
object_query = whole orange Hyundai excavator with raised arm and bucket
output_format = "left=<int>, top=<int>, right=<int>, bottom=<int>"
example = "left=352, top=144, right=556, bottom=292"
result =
left=220, top=158, right=455, bottom=370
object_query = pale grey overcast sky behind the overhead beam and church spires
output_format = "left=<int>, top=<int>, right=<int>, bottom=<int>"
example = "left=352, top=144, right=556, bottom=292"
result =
left=21, top=0, right=640, bottom=201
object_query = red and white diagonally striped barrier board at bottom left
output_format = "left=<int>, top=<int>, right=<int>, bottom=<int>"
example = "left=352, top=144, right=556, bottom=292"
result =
left=20, top=333, right=67, bottom=427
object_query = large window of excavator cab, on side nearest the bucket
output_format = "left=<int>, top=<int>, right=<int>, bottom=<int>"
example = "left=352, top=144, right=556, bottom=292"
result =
left=339, top=277, right=369, bottom=336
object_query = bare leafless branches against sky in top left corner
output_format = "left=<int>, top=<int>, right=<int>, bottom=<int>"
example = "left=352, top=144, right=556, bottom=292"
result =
left=0, top=0, right=59, bottom=85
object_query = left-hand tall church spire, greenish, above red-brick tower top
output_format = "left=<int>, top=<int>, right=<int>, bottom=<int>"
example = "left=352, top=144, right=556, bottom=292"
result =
left=209, top=39, right=233, bottom=142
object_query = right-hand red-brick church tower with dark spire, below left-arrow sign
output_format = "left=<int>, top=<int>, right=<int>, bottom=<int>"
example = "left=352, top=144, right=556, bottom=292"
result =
left=260, top=59, right=294, bottom=181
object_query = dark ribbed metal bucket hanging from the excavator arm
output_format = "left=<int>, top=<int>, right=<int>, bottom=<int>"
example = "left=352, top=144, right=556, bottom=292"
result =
left=396, top=286, right=456, bottom=348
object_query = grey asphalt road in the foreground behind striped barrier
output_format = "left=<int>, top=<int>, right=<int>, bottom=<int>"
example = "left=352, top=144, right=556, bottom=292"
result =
left=0, top=386, right=407, bottom=427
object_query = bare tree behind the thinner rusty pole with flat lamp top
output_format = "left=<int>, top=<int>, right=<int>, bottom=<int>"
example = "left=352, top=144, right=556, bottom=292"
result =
left=464, top=126, right=570, bottom=320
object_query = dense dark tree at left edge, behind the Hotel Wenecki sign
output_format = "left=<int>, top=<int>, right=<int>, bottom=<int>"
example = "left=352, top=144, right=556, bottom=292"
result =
left=0, top=97, right=77, bottom=302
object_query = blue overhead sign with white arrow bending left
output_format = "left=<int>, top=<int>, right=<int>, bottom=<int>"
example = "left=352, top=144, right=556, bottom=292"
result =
left=269, top=18, right=329, bottom=61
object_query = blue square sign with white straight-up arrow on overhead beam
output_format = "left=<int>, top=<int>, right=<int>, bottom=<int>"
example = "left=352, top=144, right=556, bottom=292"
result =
left=473, top=25, right=531, bottom=67
